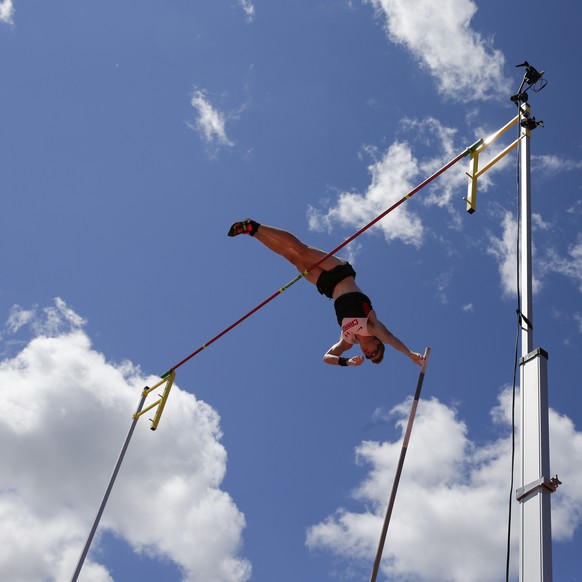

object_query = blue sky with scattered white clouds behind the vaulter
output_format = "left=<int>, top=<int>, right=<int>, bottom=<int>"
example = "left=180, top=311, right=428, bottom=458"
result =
left=0, top=0, right=582, bottom=582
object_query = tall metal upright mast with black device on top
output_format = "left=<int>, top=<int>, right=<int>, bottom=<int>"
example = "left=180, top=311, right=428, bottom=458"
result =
left=512, top=62, right=560, bottom=582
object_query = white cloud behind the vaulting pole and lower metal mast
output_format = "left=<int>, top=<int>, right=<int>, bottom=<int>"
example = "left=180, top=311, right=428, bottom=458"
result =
left=307, top=390, right=582, bottom=582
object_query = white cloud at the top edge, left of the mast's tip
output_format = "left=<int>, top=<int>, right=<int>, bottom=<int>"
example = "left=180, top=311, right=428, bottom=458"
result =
left=364, top=0, right=509, bottom=101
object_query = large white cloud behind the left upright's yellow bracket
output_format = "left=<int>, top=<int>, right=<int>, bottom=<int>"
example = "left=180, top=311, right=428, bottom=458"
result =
left=0, top=300, right=250, bottom=582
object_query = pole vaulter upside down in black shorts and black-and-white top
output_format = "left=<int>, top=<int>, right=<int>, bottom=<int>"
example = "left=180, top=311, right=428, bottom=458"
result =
left=228, top=218, right=424, bottom=366
